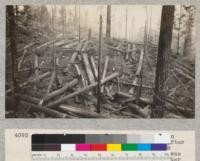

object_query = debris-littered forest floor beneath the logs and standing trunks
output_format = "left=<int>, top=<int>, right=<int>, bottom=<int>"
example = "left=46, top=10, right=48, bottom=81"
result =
left=6, top=29, right=195, bottom=118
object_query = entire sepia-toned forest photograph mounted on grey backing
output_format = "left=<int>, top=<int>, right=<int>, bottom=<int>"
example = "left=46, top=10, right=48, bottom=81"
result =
left=5, top=4, right=196, bottom=119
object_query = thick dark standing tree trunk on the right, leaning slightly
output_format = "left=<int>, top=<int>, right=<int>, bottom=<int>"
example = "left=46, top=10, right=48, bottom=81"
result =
left=151, top=5, right=175, bottom=118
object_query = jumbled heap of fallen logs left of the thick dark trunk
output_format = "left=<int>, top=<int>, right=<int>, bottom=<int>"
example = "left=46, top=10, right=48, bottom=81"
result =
left=6, top=35, right=155, bottom=118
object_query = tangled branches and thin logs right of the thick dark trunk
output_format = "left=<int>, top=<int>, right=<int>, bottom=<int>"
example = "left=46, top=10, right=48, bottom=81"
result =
left=166, top=57, right=195, bottom=118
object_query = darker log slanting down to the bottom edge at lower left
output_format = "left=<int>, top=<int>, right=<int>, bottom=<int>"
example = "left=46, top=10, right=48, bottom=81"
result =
left=20, top=101, right=68, bottom=118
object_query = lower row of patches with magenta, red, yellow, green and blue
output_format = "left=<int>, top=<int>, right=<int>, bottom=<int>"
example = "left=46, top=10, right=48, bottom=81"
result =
left=32, top=144, right=167, bottom=152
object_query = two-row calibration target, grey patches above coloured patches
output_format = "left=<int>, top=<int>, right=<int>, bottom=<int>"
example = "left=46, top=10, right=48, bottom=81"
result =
left=32, top=134, right=170, bottom=152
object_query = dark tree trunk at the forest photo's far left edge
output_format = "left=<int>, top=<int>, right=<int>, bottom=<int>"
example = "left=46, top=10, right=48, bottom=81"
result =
left=7, top=5, right=17, bottom=89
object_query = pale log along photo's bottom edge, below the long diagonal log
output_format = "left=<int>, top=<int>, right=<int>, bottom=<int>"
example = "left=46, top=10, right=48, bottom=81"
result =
left=58, top=104, right=106, bottom=118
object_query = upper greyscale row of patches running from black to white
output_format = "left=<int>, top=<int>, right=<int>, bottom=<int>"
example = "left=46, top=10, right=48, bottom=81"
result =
left=32, top=133, right=171, bottom=144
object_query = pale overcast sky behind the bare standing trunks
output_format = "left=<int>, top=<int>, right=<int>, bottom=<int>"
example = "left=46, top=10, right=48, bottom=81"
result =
left=45, top=5, right=181, bottom=41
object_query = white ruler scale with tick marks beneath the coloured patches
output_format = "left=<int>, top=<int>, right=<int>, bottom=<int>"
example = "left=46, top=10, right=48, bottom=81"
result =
left=32, top=152, right=170, bottom=161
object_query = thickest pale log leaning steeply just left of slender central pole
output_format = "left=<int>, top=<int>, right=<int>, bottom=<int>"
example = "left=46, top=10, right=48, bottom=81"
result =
left=82, top=53, right=95, bottom=84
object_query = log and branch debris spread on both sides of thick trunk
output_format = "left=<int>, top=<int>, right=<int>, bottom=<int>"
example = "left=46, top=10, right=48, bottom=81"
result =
left=6, top=37, right=194, bottom=118
